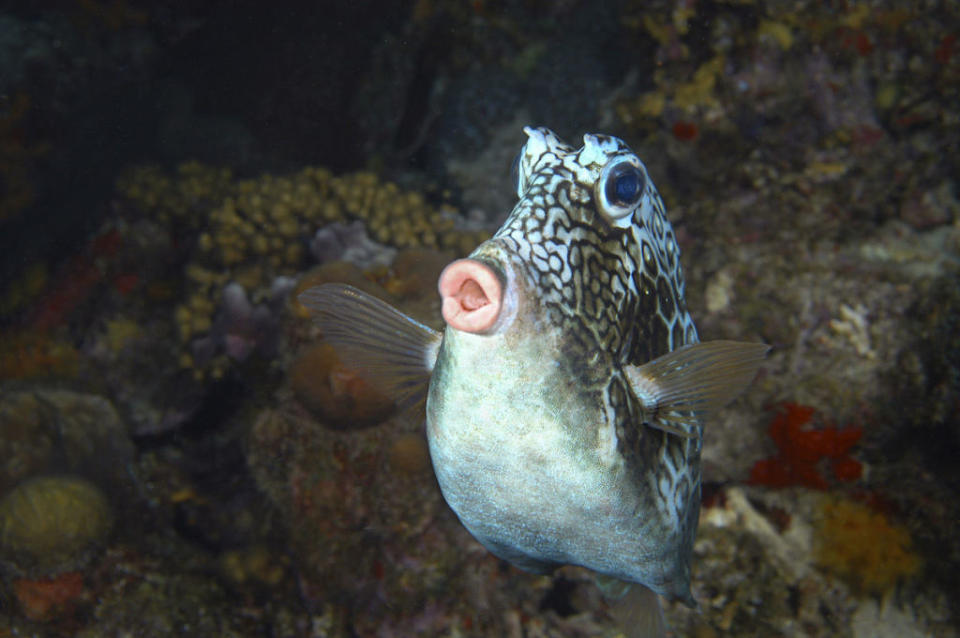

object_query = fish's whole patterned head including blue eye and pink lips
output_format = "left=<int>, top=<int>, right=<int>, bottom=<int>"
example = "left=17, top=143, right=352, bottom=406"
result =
left=439, top=127, right=696, bottom=363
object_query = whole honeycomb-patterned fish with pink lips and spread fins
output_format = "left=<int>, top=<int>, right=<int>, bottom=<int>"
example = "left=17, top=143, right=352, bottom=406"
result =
left=299, top=127, right=768, bottom=635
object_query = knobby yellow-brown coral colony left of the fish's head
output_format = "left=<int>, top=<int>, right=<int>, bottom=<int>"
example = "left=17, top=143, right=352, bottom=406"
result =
left=117, top=163, right=487, bottom=377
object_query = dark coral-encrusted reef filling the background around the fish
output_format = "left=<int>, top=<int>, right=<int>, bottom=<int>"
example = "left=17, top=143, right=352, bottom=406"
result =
left=0, top=0, right=960, bottom=638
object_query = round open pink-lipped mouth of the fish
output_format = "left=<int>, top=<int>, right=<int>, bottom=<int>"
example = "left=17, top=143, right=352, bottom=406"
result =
left=437, top=258, right=505, bottom=334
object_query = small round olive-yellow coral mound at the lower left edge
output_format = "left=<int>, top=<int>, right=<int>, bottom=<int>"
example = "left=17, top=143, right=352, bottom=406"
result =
left=0, top=476, right=113, bottom=578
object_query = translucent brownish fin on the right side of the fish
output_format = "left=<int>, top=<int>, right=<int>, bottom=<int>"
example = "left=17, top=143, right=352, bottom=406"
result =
left=624, top=341, right=770, bottom=438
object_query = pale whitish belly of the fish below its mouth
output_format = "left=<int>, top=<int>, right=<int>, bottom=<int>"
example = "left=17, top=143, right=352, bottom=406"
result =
left=427, top=328, right=660, bottom=576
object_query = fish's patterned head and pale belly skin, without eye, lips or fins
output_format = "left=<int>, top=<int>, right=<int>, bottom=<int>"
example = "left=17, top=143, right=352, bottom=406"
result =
left=427, top=129, right=701, bottom=602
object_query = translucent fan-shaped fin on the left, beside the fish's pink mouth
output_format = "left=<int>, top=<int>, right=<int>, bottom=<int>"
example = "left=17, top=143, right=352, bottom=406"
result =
left=298, top=284, right=443, bottom=410
